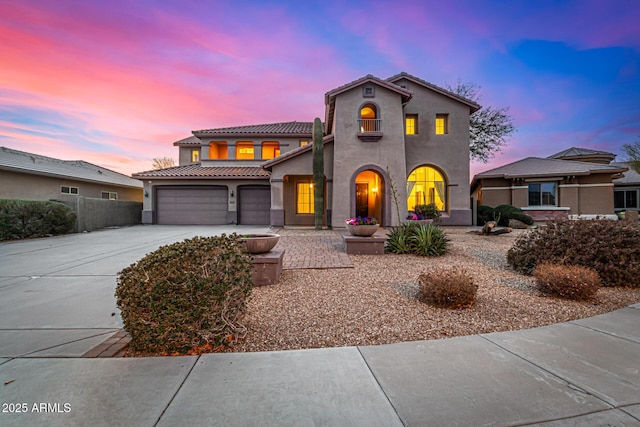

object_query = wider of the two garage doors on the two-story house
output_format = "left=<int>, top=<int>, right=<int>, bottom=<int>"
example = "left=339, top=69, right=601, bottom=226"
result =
left=156, top=187, right=227, bottom=225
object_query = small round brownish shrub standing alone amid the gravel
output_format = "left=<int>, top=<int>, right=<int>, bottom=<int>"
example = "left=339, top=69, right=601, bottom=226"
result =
left=418, top=268, right=478, bottom=308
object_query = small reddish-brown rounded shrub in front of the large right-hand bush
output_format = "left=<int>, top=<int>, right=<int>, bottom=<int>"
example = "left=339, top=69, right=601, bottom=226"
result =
left=533, top=263, right=600, bottom=300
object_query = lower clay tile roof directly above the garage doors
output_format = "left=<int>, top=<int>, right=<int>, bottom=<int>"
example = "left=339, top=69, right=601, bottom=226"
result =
left=132, top=163, right=270, bottom=179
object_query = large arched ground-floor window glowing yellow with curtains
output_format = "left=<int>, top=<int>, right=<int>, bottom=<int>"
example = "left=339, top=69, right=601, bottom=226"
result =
left=407, top=166, right=447, bottom=211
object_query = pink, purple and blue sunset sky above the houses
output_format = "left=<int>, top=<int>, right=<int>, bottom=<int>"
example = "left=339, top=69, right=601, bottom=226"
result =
left=0, top=0, right=640, bottom=175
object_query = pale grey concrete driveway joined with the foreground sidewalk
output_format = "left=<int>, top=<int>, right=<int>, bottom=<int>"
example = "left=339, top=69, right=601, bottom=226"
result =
left=0, top=226, right=640, bottom=426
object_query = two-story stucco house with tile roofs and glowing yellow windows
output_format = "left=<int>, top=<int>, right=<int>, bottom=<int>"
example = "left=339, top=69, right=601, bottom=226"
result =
left=138, top=73, right=480, bottom=227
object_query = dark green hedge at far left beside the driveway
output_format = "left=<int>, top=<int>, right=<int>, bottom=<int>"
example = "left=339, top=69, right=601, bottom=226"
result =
left=0, top=199, right=76, bottom=240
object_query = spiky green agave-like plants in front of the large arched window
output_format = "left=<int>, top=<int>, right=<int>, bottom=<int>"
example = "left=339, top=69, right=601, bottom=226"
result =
left=385, top=222, right=449, bottom=256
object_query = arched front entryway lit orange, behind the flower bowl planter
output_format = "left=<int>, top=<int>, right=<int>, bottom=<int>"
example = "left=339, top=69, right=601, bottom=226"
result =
left=352, top=169, right=386, bottom=223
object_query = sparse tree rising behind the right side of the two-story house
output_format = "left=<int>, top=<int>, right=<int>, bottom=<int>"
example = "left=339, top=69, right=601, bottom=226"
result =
left=447, top=81, right=516, bottom=163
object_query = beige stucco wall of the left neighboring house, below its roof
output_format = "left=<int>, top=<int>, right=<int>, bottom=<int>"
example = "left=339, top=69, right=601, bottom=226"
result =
left=0, top=170, right=143, bottom=202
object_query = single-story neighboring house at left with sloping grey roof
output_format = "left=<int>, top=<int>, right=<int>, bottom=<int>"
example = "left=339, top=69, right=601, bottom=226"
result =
left=0, top=147, right=143, bottom=202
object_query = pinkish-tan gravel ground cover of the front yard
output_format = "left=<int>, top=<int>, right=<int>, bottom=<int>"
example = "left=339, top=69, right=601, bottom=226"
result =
left=234, top=228, right=640, bottom=352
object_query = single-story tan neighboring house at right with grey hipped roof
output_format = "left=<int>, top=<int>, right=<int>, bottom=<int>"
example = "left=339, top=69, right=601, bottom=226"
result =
left=471, top=147, right=637, bottom=221
